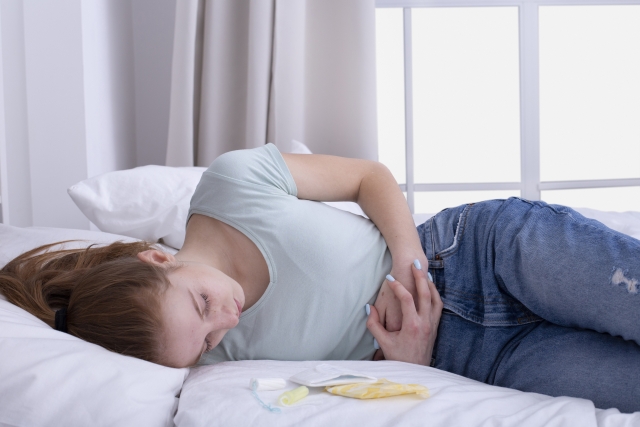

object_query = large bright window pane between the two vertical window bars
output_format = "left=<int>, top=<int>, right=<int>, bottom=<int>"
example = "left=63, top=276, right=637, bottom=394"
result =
left=412, top=7, right=520, bottom=183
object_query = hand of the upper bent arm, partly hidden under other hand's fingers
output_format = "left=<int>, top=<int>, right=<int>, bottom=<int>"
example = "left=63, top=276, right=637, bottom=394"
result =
left=374, top=251, right=429, bottom=332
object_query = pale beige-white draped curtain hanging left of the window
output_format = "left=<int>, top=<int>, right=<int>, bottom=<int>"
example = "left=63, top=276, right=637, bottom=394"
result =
left=167, top=0, right=378, bottom=166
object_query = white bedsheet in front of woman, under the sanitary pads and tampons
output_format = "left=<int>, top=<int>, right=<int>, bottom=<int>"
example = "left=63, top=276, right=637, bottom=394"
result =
left=175, top=360, right=640, bottom=427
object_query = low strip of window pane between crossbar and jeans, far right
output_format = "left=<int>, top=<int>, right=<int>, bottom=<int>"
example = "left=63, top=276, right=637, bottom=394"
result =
left=542, top=187, right=640, bottom=212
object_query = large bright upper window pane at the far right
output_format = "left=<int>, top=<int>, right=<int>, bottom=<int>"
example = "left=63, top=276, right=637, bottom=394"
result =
left=540, top=6, right=640, bottom=181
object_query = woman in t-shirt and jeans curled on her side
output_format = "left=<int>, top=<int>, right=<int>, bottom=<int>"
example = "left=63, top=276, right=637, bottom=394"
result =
left=0, top=144, right=640, bottom=412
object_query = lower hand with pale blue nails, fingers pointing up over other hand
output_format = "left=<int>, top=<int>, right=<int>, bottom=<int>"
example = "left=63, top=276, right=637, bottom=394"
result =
left=367, top=265, right=442, bottom=366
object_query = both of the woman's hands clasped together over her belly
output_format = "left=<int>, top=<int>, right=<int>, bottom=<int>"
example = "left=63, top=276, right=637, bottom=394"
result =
left=367, top=259, right=443, bottom=366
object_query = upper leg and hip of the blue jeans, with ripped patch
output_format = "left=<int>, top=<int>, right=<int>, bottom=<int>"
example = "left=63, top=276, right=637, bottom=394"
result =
left=418, top=198, right=640, bottom=344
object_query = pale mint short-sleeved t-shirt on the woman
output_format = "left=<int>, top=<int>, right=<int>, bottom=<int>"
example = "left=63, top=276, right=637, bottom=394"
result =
left=189, top=144, right=391, bottom=364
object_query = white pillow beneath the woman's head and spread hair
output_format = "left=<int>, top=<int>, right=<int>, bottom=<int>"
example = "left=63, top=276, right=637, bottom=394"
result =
left=0, top=225, right=189, bottom=427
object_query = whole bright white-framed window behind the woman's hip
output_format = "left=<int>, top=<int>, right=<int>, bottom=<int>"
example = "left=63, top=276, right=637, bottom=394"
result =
left=376, top=0, right=640, bottom=213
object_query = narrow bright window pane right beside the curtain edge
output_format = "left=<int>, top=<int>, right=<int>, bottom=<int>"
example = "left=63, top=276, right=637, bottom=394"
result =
left=376, top=8, right=406, bottom=183
